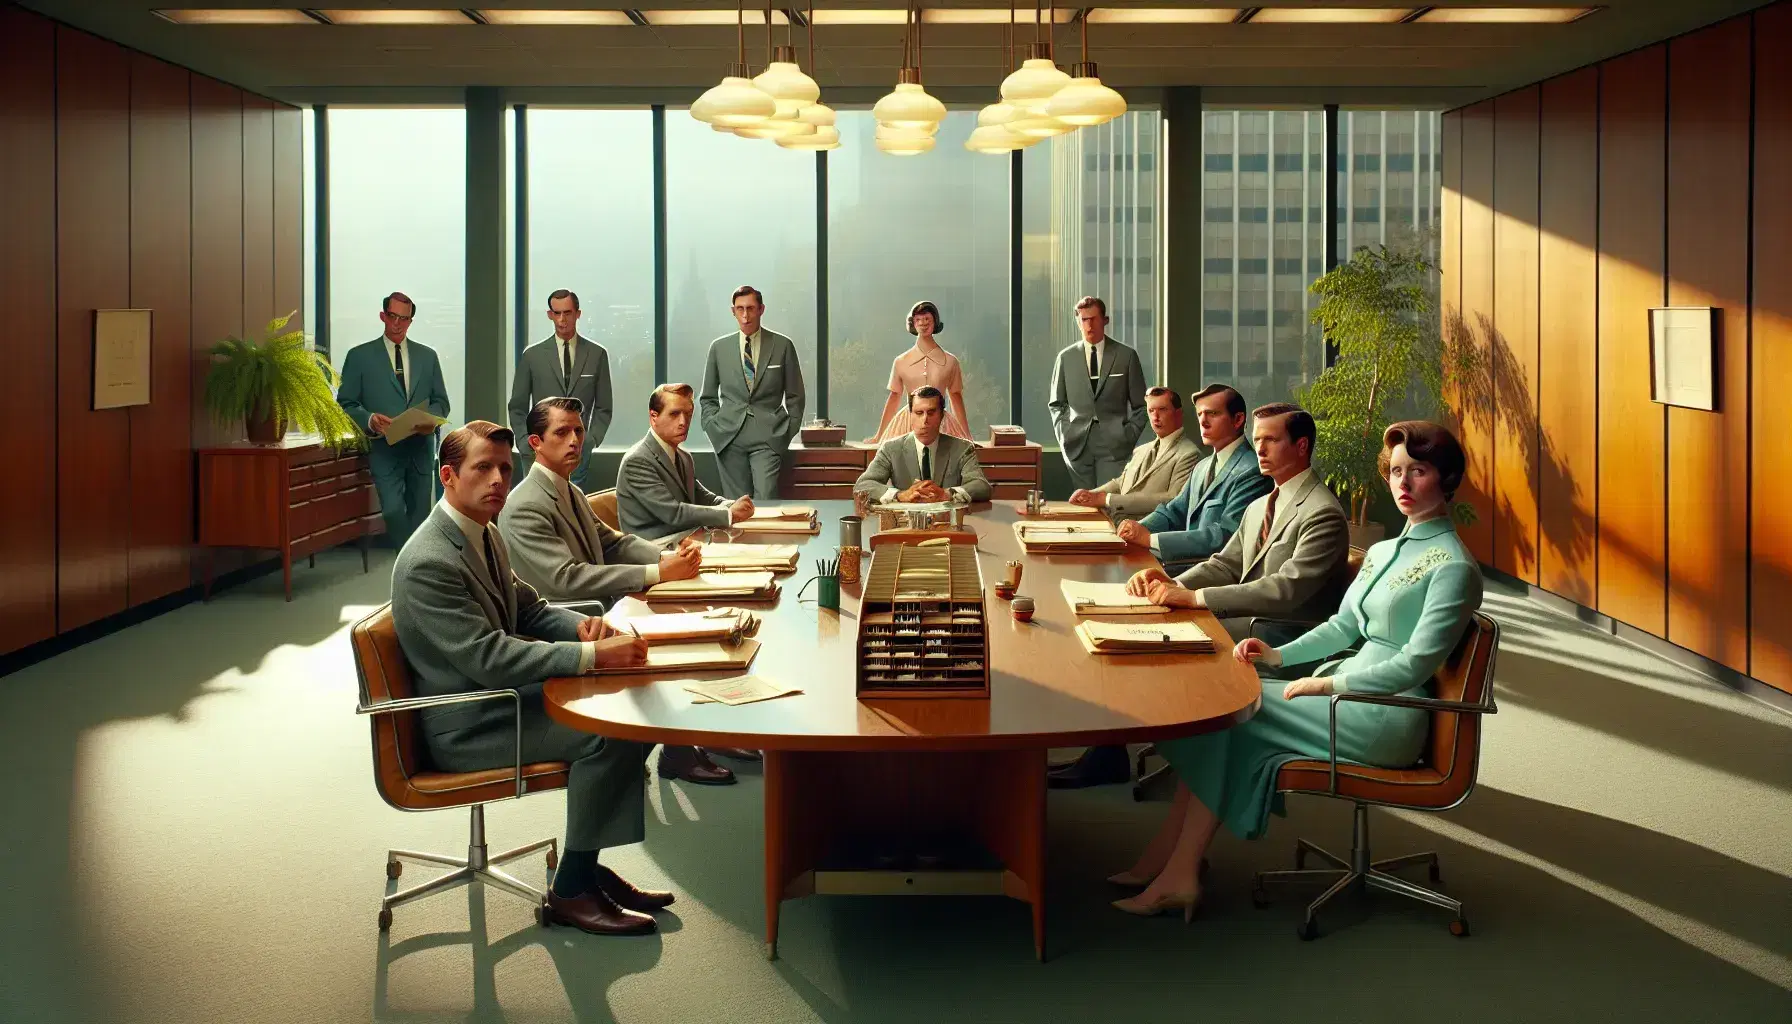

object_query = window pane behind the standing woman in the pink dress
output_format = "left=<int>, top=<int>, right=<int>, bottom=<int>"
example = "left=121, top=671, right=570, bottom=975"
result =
left=828, top=111, right=1011, bottom=438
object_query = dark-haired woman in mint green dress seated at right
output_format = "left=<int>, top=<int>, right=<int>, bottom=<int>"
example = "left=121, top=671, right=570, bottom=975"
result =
left=1109, top=420, right=1480, bottom=920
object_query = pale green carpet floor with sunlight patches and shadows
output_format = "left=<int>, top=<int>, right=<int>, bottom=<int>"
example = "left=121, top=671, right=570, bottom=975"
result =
left=0, top=552, right=1792, bottom=1024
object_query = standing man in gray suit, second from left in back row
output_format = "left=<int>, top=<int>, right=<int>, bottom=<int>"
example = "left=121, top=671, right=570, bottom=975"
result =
left=511, top=289, right=611, bottom=490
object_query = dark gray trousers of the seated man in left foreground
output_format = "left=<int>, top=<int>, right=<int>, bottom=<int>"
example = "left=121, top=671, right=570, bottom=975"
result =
left=428, top=683, right=652, bottom=850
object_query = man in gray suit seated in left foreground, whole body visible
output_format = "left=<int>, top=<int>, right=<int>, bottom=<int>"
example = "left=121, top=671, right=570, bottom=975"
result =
left=392, top=420, right=672, bottom=934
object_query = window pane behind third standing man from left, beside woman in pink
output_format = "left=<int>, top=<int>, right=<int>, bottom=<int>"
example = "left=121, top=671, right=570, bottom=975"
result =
left=666, top=109, right=820, bottom=448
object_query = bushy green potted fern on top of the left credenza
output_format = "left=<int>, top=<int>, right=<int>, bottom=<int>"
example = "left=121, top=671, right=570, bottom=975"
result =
left=206, top=310, right=362, bottom=448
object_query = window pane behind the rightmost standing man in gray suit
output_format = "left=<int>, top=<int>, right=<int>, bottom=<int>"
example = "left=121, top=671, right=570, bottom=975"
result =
left=1025, top=111, right=1163, bottom=445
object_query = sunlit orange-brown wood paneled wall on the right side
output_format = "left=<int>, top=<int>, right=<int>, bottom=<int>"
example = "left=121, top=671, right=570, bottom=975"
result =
left=1443, top=2, right=1792, bottom=690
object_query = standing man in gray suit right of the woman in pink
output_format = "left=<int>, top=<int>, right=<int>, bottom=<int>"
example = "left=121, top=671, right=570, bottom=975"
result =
left=1050, top=296, right=1145, bottom=490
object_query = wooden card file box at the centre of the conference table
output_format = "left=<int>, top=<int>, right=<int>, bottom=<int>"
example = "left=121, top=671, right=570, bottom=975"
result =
left=857, top=534, right=989, bottom=699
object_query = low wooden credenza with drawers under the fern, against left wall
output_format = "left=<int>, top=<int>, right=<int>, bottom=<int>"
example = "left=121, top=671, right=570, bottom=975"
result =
left=199, top=436, right=385, bottom=601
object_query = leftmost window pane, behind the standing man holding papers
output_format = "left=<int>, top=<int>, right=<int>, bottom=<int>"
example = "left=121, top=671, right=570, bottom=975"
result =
left=328, top=108, right=466, bottom=423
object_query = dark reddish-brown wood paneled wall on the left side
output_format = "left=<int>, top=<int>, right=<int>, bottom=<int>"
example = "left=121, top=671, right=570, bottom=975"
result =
left=0, top=4, right=303, bottom=655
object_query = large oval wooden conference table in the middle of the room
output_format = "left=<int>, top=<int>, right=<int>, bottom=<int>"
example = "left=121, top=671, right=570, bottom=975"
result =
left=547, top=502, right=1262, bottom=959
